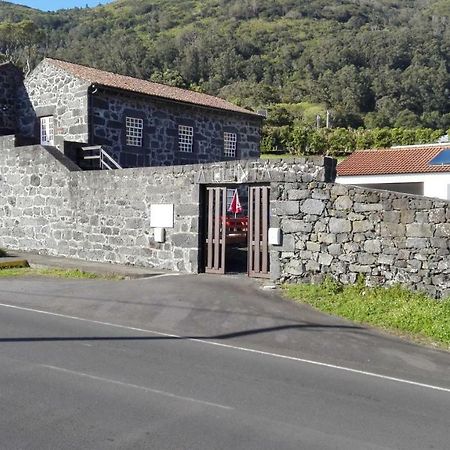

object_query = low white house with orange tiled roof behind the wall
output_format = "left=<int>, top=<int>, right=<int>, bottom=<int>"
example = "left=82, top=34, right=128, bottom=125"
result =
left=336, top=143, right=450, bottom=200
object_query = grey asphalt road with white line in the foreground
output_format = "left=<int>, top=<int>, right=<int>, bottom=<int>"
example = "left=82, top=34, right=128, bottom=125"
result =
left=0, top=276, right=450, bottom=450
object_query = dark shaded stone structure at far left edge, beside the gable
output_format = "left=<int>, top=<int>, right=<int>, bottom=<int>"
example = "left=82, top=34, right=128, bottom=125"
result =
left=0, top=64, right=23, bottom=134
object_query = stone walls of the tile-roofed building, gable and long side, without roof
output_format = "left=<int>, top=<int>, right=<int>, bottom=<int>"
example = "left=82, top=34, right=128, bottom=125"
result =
left=4, top=61, right=262, bottom=168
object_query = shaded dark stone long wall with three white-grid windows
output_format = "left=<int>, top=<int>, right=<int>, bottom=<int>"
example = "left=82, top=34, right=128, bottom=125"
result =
left=92, top=89, right=261, bottom=167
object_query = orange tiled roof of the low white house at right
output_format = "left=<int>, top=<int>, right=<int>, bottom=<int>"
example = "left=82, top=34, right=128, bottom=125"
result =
left=337, top=144, right=450, bottom=176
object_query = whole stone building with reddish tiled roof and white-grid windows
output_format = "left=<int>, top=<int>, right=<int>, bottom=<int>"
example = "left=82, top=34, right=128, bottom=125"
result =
left=0, top=58, right=262, bottom=168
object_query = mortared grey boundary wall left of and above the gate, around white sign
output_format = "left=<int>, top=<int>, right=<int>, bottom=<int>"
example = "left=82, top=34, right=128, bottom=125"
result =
left=0, top=142, right=325, bottom=273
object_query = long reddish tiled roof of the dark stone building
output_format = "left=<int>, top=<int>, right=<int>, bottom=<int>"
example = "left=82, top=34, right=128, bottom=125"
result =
left=45, top=58, right=262, bottom=118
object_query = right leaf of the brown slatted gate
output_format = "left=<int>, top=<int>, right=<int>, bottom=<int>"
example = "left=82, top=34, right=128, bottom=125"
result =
left=248, top=186, right=270, bottom=278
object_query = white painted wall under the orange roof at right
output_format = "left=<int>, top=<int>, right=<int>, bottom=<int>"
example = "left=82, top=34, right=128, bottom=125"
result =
left=336, top=172, right=450, bottom=200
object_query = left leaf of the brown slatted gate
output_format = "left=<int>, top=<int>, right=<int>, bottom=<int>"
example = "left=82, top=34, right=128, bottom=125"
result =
left=205, top=187, right=227, bottom=274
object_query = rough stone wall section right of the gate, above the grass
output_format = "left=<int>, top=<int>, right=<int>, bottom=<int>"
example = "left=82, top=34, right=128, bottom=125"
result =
left=271, top=181, right=450, bottom=297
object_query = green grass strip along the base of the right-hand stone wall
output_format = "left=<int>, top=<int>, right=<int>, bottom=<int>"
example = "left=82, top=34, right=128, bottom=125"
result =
left=284, top=279, right=450, bottom=349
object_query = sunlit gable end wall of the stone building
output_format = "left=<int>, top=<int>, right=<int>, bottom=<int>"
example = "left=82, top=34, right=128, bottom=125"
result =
left=19, top=61, right=90, bottom=151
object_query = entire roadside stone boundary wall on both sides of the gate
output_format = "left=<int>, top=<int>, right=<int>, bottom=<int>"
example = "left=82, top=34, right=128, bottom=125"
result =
left=0, top=136, right=450, bottom=297
